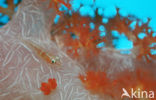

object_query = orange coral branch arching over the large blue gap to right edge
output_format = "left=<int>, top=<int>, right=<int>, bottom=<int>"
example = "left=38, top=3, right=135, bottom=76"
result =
left=105, top=9, right=156, bottom=62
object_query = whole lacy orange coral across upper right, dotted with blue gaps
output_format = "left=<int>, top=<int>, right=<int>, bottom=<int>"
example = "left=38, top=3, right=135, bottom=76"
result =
left=51, top=9, right=156, bottom=62
